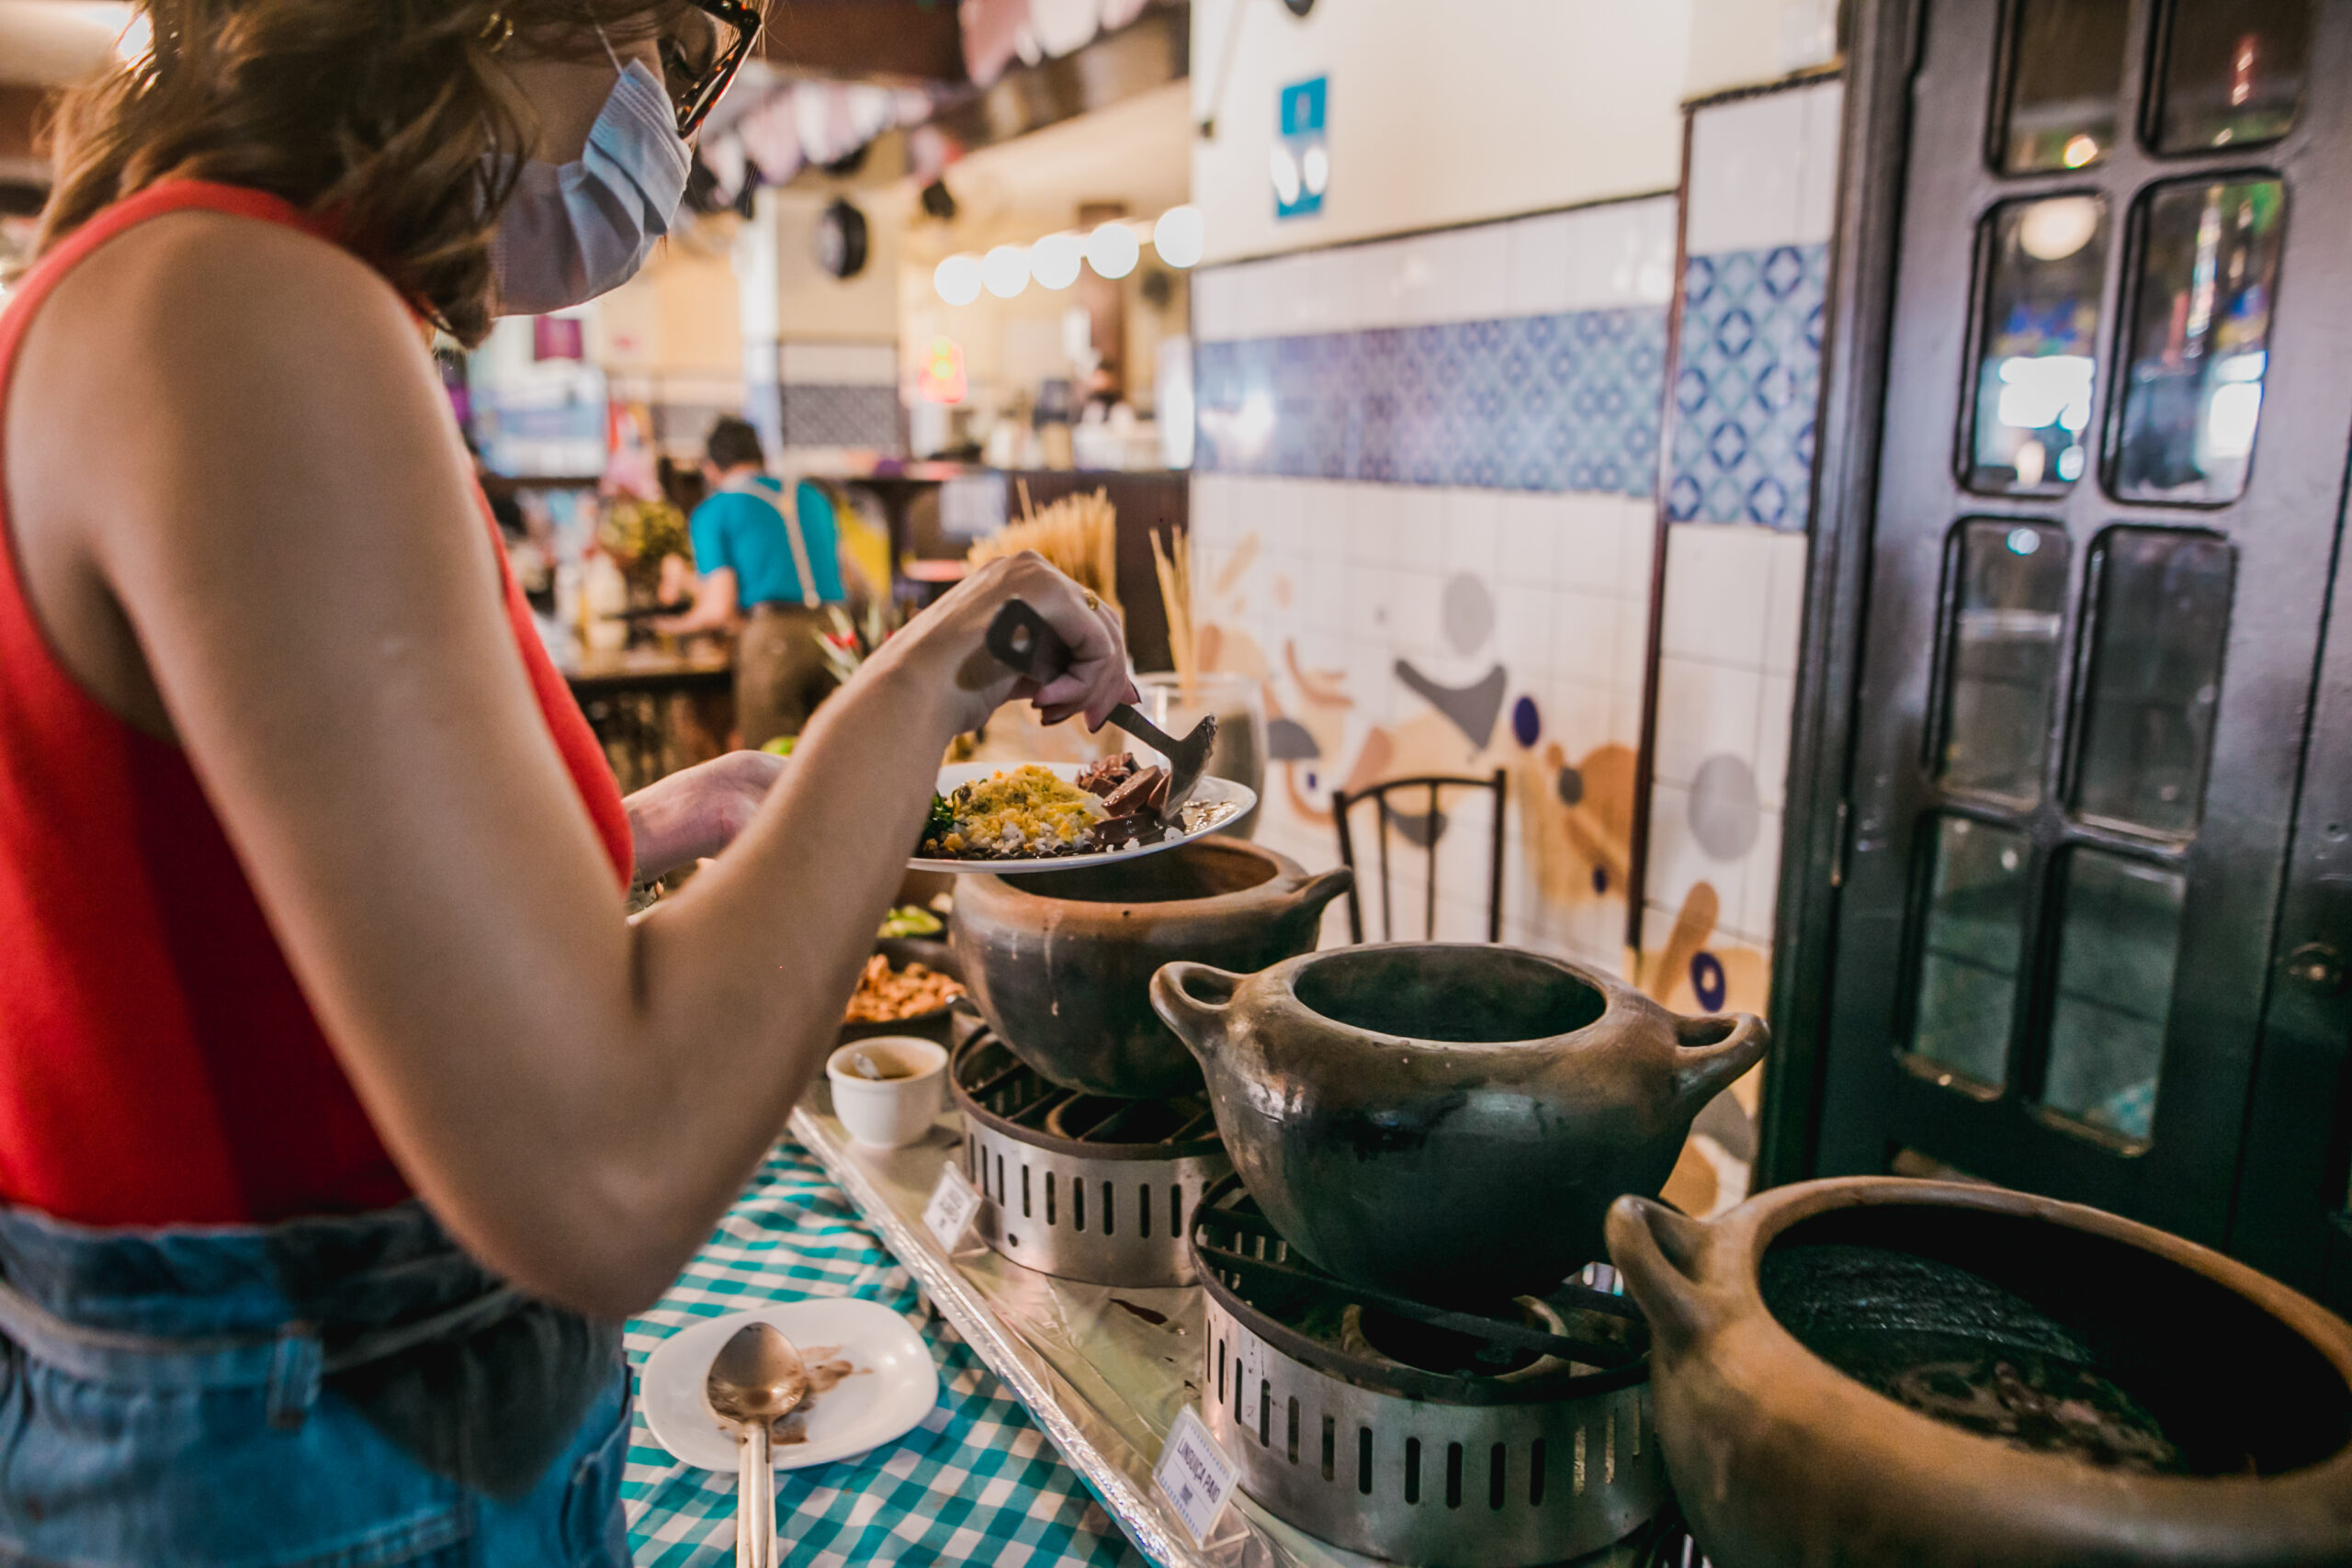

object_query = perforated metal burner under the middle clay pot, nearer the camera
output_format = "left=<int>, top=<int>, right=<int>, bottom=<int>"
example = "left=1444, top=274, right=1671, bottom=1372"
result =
left=1193, top=1180, right=1670, bottom=1568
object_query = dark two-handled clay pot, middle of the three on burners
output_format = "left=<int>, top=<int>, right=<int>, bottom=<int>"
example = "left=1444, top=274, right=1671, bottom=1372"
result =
left=1152, top=942, right=1767, bottom=1303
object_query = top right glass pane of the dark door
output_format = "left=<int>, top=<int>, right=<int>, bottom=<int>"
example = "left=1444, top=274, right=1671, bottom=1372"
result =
left=2157, top=0, right=2314, bottom=152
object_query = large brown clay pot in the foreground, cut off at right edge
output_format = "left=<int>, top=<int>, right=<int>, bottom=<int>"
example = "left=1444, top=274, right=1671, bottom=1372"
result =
left=1609, top=1178, right=2352, bottom=1568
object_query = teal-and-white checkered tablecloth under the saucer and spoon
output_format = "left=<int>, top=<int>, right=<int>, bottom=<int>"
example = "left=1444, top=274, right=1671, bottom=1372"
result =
left=621, top=1138, right=1146, bottom=1568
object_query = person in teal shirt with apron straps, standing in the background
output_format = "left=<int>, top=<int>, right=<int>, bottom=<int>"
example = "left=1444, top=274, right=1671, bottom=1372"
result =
left=656, top=416, right=849, bottom=745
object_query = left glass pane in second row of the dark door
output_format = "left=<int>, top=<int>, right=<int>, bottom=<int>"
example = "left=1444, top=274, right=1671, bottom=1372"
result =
left=1966, top=195, right=2108, bottom=493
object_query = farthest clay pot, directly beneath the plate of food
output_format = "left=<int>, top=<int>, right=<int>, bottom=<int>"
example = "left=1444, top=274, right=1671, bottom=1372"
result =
left=948, top=837, right=1350, bottom=1096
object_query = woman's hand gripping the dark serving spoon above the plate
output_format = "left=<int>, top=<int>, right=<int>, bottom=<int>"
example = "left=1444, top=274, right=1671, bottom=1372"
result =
left=875, top=550, right=1138, bottom=731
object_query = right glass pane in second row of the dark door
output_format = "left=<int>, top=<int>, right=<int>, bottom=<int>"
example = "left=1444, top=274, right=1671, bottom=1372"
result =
left=2114, top=179, right=2286, bottom=503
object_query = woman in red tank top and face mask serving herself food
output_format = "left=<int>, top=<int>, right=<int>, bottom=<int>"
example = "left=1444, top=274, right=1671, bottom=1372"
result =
left=0, top=0, right=1129, bottom=1565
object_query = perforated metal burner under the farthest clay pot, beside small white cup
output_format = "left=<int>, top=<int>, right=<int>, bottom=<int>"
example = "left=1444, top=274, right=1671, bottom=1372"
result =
left=948, top=1022, right=1232, bottom=1286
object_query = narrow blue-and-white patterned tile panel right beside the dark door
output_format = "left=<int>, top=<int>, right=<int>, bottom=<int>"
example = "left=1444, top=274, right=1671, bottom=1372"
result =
left=1665, top=244, right=1830, bottom=531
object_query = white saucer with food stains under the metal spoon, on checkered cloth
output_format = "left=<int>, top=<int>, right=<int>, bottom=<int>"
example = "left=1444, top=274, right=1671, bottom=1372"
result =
left=638, top=1295, right=938, bottom=1470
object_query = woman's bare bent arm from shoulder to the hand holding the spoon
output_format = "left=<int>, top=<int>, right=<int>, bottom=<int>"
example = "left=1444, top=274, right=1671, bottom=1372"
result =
left=5, top=214, right=1126, bottom=1316
